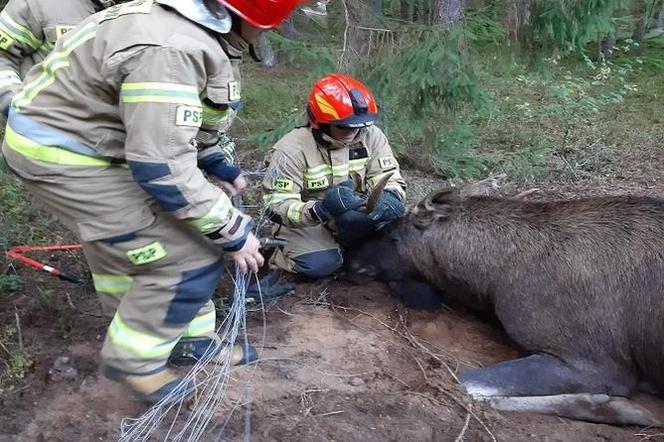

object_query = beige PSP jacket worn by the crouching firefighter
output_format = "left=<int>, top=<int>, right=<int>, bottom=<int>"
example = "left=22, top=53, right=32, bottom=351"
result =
left=263, top=126, right=406, bottom=228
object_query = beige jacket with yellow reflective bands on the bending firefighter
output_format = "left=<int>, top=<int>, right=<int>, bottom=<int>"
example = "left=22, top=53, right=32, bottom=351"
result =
left=6, top=0, right=250, bottom=250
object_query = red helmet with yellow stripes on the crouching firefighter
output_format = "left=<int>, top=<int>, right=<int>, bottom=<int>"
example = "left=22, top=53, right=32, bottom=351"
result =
left=307, top=74, right=378, bottom=129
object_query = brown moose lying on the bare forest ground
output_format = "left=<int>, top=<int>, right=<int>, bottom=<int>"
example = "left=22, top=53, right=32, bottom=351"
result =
left=347, top=189, right=664, bottom=425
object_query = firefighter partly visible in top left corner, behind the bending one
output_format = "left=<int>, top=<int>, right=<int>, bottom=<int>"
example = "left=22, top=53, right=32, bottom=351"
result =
left=0, top=0, right=122, bottom=115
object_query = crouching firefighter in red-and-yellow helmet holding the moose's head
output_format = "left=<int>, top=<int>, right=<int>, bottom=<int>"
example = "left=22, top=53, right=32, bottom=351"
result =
left=263, top=74, right=406, bottom=278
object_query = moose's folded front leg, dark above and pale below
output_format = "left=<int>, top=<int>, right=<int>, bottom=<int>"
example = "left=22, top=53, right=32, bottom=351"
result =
left=460, top=354, right=661, bottom=426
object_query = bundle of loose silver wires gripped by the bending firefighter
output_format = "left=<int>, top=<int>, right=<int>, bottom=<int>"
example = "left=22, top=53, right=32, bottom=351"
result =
left=118, top=164, right=281, bottom=442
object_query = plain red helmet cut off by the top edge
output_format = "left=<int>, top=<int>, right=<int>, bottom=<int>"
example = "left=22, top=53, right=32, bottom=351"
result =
left=217, top=0, right=305, bottom=29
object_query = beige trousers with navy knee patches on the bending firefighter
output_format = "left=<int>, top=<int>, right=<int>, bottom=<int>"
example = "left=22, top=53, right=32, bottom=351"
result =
left=3, top=147, right=222, bottom=375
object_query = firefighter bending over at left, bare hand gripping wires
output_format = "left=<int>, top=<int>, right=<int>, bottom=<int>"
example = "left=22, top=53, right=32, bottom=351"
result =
left=2, top=0, right=296, bottom=401
